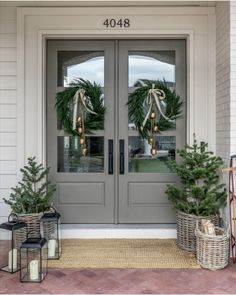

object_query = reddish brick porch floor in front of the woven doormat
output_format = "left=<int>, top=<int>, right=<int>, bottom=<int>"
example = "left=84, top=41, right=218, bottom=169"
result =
left=0, top=263, right=236, bottom=294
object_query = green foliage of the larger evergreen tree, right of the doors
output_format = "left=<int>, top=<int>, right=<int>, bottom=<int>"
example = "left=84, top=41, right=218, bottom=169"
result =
left=166, top=136, right=227, bottom=216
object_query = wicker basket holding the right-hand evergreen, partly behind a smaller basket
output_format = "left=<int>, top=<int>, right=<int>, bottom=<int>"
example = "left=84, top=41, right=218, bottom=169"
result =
left=177, top=211, right=219, bottom=253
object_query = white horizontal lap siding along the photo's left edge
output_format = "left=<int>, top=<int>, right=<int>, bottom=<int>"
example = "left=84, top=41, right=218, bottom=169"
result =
left=0, top=7, right=17, bottom=223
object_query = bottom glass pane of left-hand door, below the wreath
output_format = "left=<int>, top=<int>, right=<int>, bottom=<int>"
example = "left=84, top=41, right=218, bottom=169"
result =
left=57, top=136, right=104, bottom=173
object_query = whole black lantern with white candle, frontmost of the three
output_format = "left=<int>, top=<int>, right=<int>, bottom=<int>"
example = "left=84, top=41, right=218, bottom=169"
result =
left=20, top=233, right=48, bottom=283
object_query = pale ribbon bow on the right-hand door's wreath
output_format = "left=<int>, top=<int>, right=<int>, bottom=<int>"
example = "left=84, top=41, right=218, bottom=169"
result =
left=141, top=84, right=172, bottom=129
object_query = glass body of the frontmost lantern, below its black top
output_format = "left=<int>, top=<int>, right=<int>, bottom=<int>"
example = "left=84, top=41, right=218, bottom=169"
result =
left=20, top=243, right=48, bottom=283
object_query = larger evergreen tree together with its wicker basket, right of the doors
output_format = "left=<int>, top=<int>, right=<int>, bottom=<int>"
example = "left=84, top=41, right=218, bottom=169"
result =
left=166, top=135, right=227, bottom=252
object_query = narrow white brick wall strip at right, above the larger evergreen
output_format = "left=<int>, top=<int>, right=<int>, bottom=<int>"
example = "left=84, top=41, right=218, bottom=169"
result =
left=216, top=2, right=230, bottom=162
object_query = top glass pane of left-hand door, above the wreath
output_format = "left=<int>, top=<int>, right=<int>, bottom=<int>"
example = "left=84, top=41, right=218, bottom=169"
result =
left=57, top=51, right=104, bottom=87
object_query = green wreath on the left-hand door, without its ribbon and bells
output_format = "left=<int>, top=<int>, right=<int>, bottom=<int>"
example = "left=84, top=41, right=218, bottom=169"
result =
left=56, top=78, right=106, bottom=136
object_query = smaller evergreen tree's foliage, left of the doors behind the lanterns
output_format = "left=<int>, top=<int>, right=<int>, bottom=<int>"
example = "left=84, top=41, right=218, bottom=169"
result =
left=3, top=157, right=56, bottom=214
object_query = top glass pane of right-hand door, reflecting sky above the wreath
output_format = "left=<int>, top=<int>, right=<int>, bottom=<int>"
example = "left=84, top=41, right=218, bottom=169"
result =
left=129, top=51, right=175, bottom=87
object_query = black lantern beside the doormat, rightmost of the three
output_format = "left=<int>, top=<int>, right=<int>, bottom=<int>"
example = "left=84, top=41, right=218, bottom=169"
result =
left=40, top=208, right=61, bottom=259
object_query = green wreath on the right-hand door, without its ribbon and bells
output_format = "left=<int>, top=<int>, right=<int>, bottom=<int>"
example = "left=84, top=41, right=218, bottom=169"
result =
left=127, top=79, right=183, bottom=139
